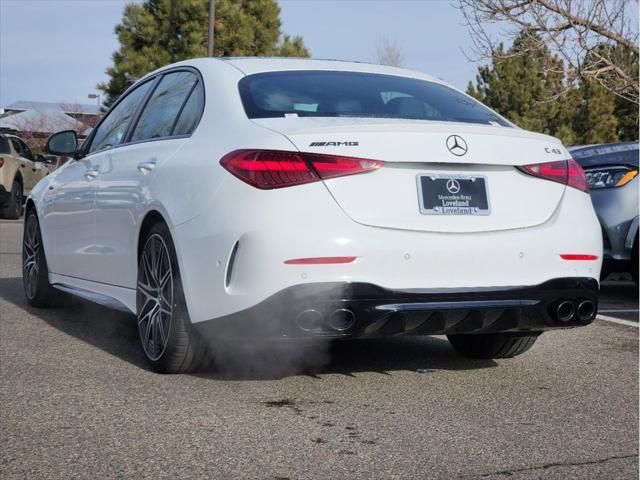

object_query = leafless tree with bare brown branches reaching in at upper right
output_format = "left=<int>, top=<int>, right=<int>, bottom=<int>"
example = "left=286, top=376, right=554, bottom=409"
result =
left=458, top=0, right=640, bottom=104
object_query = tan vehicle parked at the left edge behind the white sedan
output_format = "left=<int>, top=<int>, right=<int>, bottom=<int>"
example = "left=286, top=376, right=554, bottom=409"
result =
left=0, top=129, right=48, bottom=219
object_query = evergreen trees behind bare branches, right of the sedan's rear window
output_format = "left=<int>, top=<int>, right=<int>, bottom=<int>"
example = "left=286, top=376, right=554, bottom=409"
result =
left=467, top=28, right=638, bottom=145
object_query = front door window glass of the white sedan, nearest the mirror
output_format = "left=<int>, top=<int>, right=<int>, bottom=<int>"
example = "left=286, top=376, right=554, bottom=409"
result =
left=88, top=80, right=153, bottom=153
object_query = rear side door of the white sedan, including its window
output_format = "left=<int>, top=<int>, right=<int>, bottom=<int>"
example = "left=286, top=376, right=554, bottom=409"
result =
left=96, top=71, right=203, bottom=288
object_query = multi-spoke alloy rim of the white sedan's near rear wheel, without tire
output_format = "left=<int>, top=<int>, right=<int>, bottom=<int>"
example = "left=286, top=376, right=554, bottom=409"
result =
left=137, top=234, right=173, bottom=361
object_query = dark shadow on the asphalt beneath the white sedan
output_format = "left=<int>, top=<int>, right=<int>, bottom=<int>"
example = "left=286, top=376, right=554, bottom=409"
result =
left=0, top=277, right=497, bottom=380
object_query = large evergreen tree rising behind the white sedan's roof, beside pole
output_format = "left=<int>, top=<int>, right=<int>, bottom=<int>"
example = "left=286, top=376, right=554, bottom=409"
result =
left=98, top=0, right=309, bottom=106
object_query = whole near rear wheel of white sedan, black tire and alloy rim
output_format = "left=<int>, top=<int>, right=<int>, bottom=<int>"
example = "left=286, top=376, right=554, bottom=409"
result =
left=136, top=223, right=209, bottom=373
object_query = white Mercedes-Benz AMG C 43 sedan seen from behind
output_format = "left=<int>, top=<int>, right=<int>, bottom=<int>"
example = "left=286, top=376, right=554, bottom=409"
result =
left=23, top=58, right=602, bottom=372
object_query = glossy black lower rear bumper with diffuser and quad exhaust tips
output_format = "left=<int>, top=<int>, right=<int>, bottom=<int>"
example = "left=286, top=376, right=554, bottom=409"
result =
left=194, top=277, right=598, bottom=338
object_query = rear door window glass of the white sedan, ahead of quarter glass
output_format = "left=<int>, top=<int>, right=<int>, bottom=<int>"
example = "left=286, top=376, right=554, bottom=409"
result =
left=131, top=72, right=198, bottom=142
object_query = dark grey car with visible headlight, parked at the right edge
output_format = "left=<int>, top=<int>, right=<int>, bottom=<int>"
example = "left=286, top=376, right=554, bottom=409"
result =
left=569, top=142, right=639, bottom=283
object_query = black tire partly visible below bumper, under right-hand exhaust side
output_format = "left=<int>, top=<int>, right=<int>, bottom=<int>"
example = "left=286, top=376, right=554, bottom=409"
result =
left=447, top=333, right=539, bottom=359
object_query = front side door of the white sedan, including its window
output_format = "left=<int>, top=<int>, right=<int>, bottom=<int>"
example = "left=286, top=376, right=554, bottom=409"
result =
left=45, top=82, right=151, bottom=282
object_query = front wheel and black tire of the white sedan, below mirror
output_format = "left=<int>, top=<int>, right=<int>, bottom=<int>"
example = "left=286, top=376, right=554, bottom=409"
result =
left=22, top=209, right=70, bottom=307
